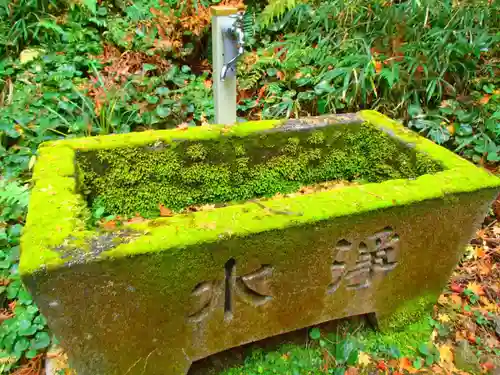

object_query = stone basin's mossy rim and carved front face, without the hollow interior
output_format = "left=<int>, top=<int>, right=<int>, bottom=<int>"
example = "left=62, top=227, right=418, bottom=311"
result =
left=20, top=111, right=500, bottom=375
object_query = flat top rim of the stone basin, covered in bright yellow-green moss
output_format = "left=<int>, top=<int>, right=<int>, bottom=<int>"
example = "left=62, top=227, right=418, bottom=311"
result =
left=20, top=111, right=500, bottom=274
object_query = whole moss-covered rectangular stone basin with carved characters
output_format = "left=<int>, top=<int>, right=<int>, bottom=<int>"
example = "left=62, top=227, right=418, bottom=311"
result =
left=20, top=111, right=500, bottom=375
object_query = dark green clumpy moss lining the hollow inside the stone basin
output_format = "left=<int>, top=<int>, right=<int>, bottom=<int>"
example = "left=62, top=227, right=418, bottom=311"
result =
left=77, top=124, right=441, bottom=217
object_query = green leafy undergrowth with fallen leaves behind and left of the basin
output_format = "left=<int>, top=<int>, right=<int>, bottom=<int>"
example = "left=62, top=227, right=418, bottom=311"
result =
left=0, top=0, right=500, bottom=373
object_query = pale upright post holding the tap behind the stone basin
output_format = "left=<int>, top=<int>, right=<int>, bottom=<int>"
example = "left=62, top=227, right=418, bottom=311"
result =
left=211, top=6, right=240, bottom=125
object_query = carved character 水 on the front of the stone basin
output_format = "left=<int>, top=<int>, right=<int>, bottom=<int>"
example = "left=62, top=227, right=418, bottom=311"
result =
left=188, top=259, right=273, bottom=323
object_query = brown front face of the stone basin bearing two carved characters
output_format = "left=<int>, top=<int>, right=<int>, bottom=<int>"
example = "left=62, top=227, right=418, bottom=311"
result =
left=24, top=189, right=496, bottom=375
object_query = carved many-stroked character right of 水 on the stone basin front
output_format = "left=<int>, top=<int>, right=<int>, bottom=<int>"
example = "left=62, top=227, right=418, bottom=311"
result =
left=328, top=228, right=399, bottom=293
